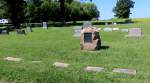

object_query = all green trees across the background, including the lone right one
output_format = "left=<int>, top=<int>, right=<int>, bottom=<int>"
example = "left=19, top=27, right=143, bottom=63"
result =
left=0, top=0, right=134, bottom=28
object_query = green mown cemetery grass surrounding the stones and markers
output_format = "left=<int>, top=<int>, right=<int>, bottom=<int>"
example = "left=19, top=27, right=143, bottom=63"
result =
left=0, top=20, right=150, bottom=83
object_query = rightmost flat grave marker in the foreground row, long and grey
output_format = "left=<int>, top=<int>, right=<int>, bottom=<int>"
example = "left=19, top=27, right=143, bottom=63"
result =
left=113, top=68, right=136, bottom=75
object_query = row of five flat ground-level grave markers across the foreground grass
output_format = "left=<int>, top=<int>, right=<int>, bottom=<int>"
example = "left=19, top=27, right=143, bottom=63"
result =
left=4, top=57, right=136, bottom=75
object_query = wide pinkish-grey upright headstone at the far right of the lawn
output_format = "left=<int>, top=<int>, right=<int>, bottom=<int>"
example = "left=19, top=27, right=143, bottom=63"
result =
left=126, top=28, right=142, bottom=37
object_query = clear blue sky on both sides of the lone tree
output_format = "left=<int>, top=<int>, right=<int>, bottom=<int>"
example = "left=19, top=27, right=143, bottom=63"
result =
left=82, top=0, right=150, bottom=19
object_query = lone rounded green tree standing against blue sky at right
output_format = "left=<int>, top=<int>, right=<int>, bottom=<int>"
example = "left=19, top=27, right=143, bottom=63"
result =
left=113, top=0, right=135, bottom=18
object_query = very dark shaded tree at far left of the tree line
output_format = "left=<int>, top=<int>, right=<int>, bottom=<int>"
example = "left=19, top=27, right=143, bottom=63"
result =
left=4, top=0, right=25, bottom=29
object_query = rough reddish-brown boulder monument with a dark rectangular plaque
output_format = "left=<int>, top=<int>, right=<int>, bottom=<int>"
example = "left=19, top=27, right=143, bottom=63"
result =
left=80, top=27, right=101, bottom=51
